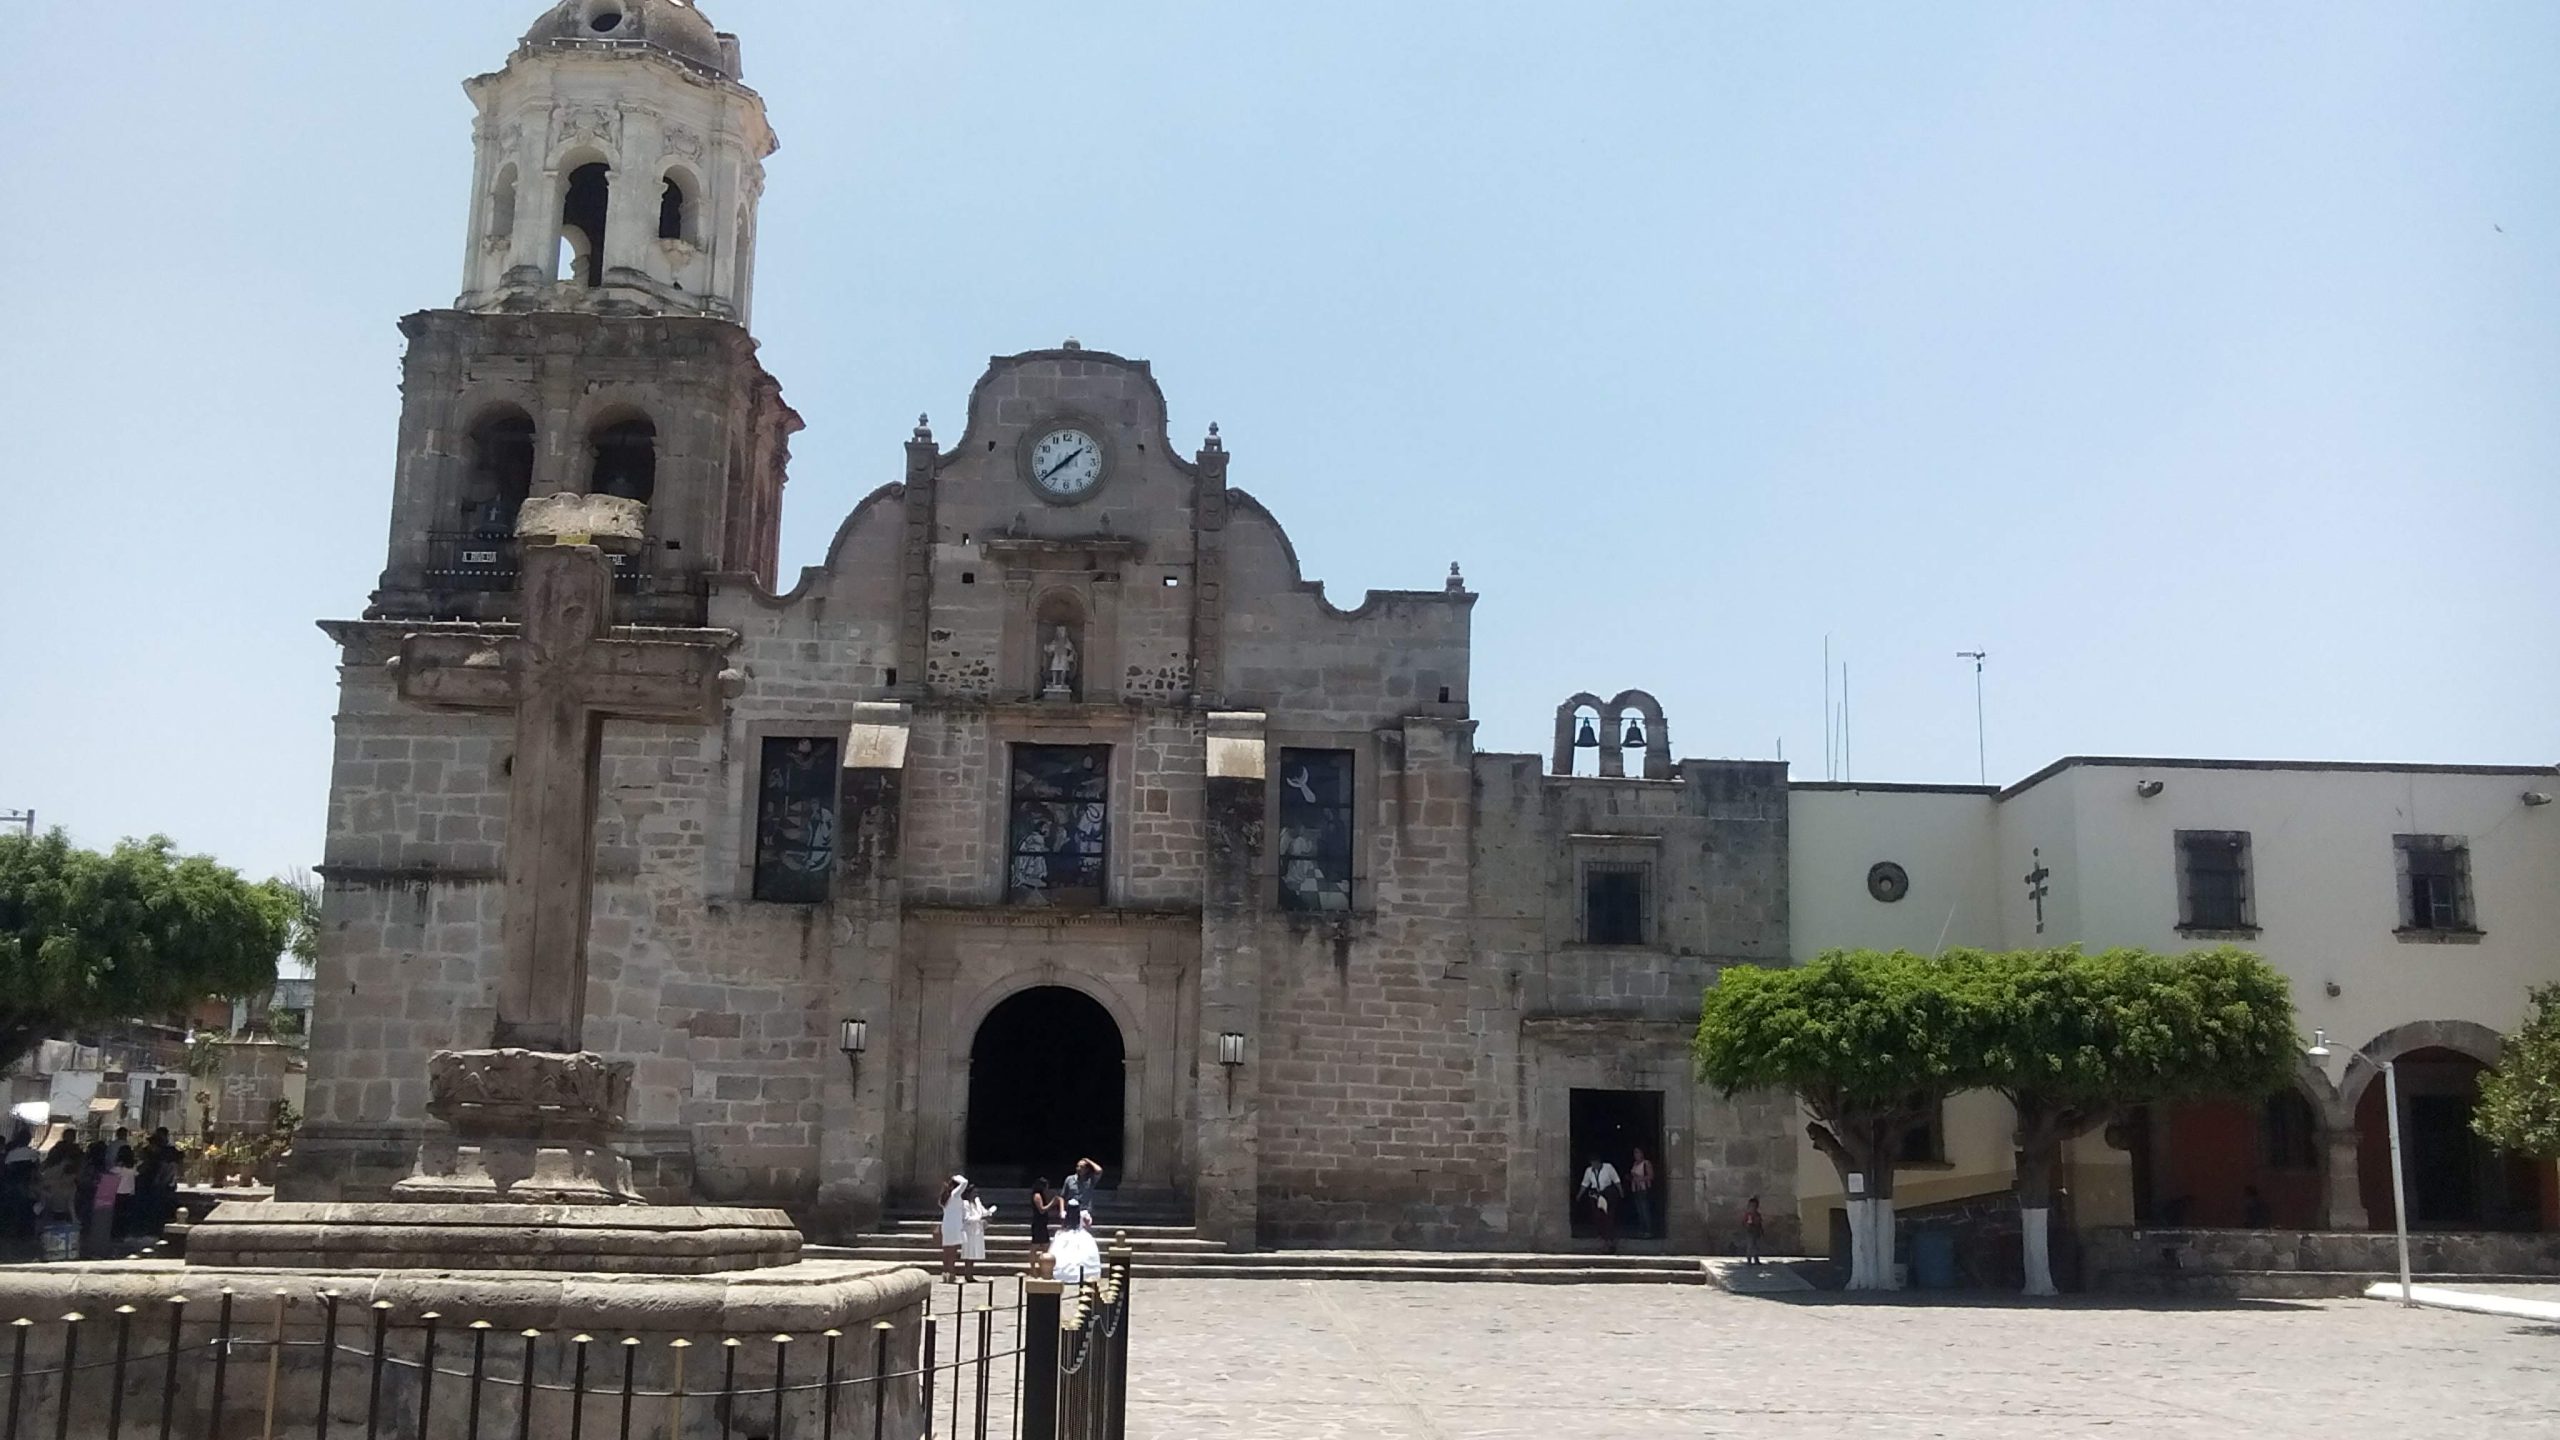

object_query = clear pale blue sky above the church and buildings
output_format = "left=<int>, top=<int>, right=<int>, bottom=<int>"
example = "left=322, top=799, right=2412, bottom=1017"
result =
left=0, top=0, right=2560, bottom=874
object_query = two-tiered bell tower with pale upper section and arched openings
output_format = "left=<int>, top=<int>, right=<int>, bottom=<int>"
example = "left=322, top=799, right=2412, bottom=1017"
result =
left=369, top=0, right=801, bottom=625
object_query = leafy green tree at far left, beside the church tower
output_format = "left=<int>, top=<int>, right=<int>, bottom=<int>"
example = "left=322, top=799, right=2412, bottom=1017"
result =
left=0, top=830, right=294, bottom=1056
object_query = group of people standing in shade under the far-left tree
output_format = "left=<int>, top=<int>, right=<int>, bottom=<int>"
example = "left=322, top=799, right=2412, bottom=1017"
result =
left=0, top=1122, right=184, bottom=1261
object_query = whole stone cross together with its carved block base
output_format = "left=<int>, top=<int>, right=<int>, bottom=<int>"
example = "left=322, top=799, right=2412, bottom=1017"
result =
left=394, top=495, right=737, bottom=1204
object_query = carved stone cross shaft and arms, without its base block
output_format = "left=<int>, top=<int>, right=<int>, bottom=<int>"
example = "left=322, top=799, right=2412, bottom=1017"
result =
left=397, top=497, right=735, bottom=1053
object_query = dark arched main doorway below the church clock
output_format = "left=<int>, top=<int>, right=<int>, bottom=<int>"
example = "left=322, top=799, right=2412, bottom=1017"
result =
left=965, top=984, right=1124, bottom=1186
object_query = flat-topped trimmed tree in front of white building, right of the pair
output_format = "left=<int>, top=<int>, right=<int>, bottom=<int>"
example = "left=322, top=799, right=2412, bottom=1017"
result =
left=1948, top=945, right=2301, bottom=1294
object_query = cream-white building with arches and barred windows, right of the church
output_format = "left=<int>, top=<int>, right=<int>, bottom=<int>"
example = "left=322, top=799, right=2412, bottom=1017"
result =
left=1789, top=756, right=2560, bottom=1248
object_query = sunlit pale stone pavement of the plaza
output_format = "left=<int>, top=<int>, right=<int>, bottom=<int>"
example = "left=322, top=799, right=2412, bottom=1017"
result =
left=1129, top=1279, right=2560, bottom=1440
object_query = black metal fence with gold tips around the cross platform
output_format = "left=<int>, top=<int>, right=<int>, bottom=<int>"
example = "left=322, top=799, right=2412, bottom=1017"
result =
left=0, top=1248, right=1129, bottom=1440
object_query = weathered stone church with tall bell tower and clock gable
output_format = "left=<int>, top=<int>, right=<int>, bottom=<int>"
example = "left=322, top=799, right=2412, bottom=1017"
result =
left=287, top=0, right=1797, bottom=1248
